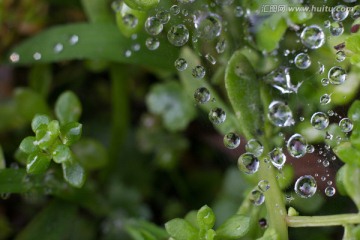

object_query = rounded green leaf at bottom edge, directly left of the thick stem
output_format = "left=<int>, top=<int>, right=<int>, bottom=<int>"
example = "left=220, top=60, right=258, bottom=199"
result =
left=216, top=214, right=250, bottom=239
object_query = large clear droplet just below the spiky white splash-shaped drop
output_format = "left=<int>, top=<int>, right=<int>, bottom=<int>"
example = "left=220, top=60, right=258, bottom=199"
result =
left=268, top=101, right=295, bottom=127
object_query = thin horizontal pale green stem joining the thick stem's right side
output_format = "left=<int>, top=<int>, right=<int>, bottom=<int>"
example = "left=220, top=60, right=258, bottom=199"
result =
left=286, top=214, right=360, bottom=227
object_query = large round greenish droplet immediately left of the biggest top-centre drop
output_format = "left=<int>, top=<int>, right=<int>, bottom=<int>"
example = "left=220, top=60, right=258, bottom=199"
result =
left=194, top=13, right=222, bottom=40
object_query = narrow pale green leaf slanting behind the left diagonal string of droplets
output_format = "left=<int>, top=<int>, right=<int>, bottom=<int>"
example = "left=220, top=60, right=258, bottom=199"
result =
left=179, top=48, right=240, bottom=134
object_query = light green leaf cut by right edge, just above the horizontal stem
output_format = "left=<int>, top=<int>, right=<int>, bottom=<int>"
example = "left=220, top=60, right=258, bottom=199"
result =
left=343, top=164, right=360, bottom=210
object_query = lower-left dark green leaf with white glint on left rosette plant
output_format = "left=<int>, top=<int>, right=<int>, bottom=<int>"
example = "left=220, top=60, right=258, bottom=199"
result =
left=26, top=152, right=51, bottom=174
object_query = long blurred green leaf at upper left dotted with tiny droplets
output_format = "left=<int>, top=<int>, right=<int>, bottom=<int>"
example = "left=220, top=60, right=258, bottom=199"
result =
left=10, top=23, right=178, bottom=69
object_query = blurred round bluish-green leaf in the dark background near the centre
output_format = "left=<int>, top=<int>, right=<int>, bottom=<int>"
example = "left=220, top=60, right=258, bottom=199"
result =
left=146, top=81, right=195, bottom=131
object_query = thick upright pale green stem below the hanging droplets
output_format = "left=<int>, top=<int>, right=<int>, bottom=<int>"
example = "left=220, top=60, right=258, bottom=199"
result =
left=259, top=155, right=288, bottom=239
